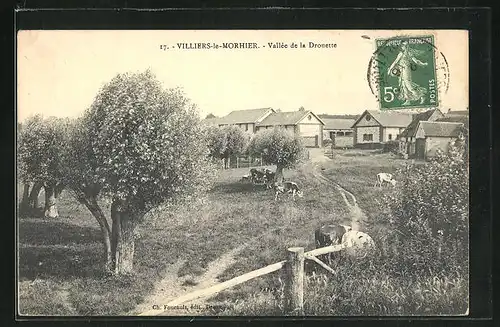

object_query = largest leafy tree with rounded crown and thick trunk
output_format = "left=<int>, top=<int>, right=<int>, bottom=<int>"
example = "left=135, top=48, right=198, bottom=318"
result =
left=81, top=71, right=215, bottom=274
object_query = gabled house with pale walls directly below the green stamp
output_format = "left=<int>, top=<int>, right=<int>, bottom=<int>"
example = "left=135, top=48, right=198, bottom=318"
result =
left=352, top=110, right=413, bottom=148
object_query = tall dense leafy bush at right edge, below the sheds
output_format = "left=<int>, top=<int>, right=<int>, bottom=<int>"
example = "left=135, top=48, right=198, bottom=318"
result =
left=381, top=135, right=469, bottom=276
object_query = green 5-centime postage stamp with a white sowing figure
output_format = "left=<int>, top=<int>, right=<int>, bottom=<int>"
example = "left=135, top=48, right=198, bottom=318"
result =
left=374, top=35, right=439, bottom=110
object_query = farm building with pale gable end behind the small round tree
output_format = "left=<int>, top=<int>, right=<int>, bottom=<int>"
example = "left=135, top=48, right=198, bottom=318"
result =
left=256, top=111, right=325, bottom=148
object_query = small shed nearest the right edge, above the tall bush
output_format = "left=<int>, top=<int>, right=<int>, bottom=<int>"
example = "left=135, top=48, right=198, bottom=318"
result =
left=414, top=121, right=464, bottom=159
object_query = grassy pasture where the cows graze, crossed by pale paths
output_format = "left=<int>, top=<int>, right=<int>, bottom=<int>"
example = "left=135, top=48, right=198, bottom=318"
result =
left=19, top=150, right=467, bottom=315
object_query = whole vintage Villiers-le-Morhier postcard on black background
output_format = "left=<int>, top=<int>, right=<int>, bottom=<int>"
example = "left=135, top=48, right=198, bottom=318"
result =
left=17, top=29, right=469, bottom=317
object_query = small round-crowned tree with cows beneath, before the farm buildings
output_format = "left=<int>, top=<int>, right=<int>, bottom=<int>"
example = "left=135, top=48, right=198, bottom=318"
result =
left=249, top=127, right=305, bottom=182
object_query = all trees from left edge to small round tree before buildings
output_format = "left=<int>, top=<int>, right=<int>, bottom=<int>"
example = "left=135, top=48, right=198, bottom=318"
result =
left=17, top=70, right=304, bottom=274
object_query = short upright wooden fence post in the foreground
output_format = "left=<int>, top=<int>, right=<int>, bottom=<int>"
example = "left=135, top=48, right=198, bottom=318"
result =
left=284, top=247, right=304, bottom=316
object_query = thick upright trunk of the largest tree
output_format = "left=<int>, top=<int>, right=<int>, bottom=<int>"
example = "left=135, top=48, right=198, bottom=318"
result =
left=111, top=201, right=136, bottom=275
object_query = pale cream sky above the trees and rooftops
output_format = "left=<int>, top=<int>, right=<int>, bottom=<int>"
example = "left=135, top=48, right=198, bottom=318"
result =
left=17, top=30, right=469, bottom=121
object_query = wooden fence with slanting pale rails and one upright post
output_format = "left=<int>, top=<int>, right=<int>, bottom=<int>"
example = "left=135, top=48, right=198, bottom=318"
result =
left=139, top=244, right=347, bottom=316
